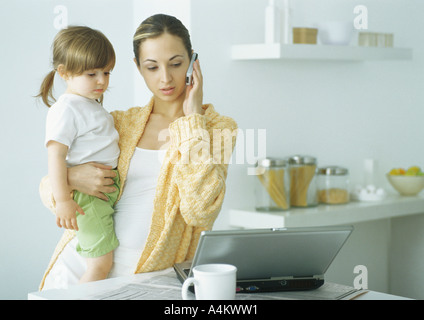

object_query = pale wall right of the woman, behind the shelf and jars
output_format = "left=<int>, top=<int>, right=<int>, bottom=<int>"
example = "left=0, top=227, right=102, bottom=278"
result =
left=192, top=0, right=424, bottom=228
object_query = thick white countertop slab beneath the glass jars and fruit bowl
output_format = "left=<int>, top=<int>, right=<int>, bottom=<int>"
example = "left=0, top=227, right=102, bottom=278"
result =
left=229, top=195, right=424, bottom=229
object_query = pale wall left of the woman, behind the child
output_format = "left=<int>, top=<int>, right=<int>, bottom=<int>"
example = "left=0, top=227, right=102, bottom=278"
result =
left=0, top=0, right=133, bottom=299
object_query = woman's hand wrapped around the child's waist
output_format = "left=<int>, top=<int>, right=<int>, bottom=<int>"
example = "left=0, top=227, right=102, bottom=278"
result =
left=68, top=162, right=116, bottom=201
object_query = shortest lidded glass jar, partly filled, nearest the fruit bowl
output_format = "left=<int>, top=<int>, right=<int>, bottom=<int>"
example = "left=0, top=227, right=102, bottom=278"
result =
left=318, top=166, right=349, bottom=204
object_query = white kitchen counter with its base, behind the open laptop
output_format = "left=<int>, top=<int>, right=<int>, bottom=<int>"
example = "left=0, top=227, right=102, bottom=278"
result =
left=229, top=195, right=424, bottom=299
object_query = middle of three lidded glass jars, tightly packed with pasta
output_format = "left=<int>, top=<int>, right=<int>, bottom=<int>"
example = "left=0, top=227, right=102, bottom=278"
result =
left=288, top=155, right=318, bottom=207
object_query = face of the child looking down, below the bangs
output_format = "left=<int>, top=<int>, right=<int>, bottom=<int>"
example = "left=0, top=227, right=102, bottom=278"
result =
left=65, top=69, right=110, bottom=99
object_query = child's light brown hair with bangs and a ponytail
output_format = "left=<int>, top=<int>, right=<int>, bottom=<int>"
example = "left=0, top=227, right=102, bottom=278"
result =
left=37, top=26, right=116, bottom=107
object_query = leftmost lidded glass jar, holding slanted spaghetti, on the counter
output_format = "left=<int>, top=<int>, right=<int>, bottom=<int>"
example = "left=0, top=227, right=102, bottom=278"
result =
left=255, top=158, right=290, bottom=211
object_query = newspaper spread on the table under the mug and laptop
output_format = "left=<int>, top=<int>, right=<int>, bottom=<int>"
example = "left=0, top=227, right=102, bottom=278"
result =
left=84, top=268, right=367, bottom=300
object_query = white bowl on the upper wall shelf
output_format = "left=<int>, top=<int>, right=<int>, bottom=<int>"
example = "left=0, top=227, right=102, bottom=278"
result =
left=316, top=21, right=353, bottom=45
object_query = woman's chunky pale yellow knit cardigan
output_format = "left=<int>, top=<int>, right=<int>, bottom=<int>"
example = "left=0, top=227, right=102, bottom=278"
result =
left=40, top=98, right=237, bottom=290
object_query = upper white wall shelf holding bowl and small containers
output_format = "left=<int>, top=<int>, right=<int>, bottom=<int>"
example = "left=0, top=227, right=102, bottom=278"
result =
left=231, top=43, right=412, bottom=61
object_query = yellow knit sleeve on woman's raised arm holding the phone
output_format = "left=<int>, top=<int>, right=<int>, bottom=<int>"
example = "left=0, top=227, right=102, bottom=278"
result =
left=170, top=113, right=237, bottom=229
